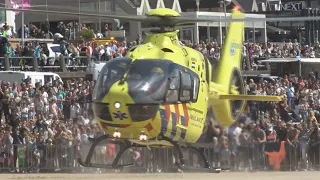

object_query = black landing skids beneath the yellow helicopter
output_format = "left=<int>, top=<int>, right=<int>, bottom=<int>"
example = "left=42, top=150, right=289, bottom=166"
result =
left=78, top=135, right=221, bottom=173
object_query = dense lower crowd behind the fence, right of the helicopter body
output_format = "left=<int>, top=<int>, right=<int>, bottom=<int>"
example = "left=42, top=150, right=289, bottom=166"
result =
left=201, top=73, right=320, bottom=170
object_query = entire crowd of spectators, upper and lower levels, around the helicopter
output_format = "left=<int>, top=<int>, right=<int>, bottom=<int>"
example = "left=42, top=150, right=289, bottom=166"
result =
left=0, top=19, right=320, bottom=172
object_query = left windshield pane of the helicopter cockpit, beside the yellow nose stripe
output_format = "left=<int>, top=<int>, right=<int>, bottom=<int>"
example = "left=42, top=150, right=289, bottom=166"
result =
left=93, top=58, right=131, bottom=101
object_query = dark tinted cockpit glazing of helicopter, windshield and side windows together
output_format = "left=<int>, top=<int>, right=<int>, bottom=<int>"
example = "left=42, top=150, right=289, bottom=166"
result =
left=93, top=58, right=200, bottom=105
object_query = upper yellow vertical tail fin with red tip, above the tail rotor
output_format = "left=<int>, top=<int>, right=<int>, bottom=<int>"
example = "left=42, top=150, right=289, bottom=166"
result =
left=214, top=10, right=244, bottom=86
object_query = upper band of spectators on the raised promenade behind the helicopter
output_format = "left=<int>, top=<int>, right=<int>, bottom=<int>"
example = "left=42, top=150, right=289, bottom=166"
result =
left=2, top=30, right=320, bottom=70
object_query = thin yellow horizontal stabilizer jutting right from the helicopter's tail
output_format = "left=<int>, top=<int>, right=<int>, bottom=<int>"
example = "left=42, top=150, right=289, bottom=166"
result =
left=219, top=95, right=283, bottom=101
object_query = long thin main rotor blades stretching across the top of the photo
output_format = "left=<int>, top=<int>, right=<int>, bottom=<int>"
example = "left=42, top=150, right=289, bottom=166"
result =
left=0, top=7, right=320, bottom=25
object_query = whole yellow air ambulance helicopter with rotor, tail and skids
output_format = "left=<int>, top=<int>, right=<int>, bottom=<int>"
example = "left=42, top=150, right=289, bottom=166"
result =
left=0, top=5, right=297, bottom=170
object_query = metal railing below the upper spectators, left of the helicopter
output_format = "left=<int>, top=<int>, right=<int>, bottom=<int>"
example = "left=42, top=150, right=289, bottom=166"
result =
left=0, top=55, right=99, bottom=72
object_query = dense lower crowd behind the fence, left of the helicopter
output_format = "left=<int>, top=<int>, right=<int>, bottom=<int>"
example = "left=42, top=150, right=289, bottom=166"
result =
left=0, top=79, right=104, bottom=171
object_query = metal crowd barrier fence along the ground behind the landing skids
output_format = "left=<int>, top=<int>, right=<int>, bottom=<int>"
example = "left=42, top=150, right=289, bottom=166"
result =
left=0, top=142, right=320, bottom=173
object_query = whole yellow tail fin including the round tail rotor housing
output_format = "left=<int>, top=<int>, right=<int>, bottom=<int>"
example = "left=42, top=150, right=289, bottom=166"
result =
left=210, top=10, right=246, bottom=126
